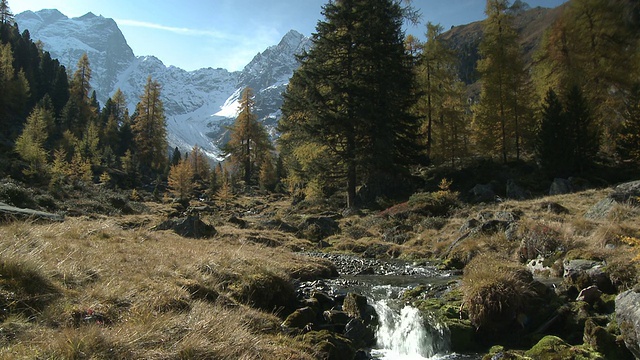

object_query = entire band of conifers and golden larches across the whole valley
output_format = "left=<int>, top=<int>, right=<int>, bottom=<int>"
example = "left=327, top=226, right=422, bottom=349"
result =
left=0, top=0, right=640, bottom=206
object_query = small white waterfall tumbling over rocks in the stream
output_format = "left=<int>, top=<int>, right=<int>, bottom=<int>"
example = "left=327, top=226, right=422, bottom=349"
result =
left=372, top=299, right=450, bottom=360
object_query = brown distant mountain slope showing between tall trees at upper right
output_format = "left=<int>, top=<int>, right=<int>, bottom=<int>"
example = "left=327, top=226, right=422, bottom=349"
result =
left=442, top=3, right=567, bottom=84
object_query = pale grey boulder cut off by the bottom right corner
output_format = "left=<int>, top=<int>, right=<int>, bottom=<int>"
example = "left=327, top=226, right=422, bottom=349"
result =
left=616, top=290, right=640, bottom=359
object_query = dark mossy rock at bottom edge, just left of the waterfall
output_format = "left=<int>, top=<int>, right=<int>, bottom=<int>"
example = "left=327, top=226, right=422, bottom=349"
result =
left=296, top=330, right=356, bottom=360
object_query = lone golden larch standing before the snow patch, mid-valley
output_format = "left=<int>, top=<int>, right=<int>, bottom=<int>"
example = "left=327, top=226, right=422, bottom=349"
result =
left=223, top=88, right=272, bottom=185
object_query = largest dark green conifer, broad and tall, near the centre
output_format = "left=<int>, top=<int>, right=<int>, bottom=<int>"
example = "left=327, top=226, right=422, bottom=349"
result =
left=279, top=0, right=422, bottom=207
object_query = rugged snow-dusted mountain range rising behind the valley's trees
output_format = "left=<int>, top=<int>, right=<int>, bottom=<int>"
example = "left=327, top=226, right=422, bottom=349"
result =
left=15, top=10, right=311, bottom=158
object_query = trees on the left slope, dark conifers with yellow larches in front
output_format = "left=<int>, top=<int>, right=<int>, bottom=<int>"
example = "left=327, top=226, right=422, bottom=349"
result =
left=0, top=4, right=168, bottom=189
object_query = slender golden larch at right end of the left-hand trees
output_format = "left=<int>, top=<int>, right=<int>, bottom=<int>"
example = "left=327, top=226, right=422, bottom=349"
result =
left=131, top=76, right=168, bottom=173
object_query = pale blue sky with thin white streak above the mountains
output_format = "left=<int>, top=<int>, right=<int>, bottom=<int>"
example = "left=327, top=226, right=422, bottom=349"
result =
left=9, top=0, right=566, bottom=71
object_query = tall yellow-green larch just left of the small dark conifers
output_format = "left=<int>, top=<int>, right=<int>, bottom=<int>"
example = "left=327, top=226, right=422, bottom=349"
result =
left=474, top=0, right=532, bottom=163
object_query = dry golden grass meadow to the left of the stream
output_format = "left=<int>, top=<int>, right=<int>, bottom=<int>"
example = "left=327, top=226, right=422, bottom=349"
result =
left=0, top=212, right=331, bottom=359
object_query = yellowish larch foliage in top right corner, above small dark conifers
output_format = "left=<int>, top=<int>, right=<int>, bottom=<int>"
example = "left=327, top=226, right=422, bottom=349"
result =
left=535, top=0, right=640, bottom=151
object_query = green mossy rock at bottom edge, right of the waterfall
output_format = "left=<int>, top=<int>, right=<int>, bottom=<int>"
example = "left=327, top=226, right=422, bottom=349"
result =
left=525, top=335, right=605, bottom=360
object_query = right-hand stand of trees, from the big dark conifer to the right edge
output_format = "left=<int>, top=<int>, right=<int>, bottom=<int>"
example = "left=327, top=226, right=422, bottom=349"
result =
left=279, top=0, right=640, bottom=206
